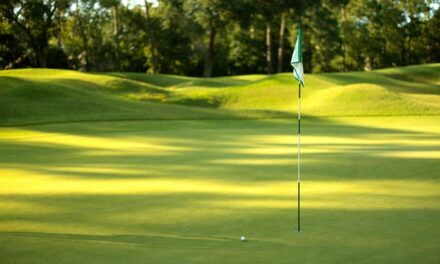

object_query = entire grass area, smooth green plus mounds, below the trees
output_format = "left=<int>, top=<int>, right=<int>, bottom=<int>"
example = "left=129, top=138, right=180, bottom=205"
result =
left=0, top=65, right=440, bottom=264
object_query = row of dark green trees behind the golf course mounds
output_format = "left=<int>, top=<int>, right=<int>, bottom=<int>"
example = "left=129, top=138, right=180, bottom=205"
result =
left=0, top=0, right=440, bottom=77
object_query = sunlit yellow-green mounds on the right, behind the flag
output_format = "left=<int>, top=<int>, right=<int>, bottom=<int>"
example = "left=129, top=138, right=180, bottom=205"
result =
left=165, top=64, right=440, bottom=116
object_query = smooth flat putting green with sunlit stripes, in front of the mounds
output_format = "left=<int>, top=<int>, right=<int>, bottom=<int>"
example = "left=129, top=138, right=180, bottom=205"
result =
left=0, top=116, right=440, bottom=263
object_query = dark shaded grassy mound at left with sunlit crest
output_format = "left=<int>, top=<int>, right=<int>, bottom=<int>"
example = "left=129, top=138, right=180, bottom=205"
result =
left=0, top=70, right=237, bottom=125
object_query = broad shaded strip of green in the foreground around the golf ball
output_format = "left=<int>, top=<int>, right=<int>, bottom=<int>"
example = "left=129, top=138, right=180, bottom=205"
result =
left=0, top=195, right=440, bottom=263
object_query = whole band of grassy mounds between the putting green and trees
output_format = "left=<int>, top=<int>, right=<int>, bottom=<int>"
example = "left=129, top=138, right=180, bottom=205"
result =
left=0, top=64, right=440, bottom=125
